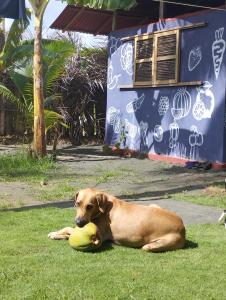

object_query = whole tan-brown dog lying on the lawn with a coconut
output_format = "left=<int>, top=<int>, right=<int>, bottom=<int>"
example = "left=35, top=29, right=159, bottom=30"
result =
left=48, top=188, right=185, bottom=252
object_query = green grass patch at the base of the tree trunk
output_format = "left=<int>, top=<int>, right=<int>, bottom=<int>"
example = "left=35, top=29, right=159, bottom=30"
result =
left=0, top=151, right=56, bottom=181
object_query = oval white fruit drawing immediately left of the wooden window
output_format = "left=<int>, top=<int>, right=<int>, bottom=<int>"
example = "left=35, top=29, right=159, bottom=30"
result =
left=120, top=43, right=133, bottom=75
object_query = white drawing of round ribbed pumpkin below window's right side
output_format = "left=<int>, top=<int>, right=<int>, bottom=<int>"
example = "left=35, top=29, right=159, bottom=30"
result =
left=171, top=88, right=191, bottom=120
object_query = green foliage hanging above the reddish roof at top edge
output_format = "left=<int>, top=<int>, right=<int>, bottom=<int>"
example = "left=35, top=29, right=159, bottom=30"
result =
left=66, top=0, right=137, bottom=10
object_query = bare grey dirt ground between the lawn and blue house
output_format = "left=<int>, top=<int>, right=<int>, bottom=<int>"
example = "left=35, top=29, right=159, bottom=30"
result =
left=0, top=145, right=226, bottom=223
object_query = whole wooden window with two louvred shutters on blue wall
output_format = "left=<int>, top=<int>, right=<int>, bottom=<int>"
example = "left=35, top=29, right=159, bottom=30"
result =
left=134, top=29, right=180, bottom=86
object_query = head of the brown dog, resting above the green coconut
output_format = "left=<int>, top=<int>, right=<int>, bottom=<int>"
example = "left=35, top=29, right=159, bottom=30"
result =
left=75, top=188, right=108, bottom=227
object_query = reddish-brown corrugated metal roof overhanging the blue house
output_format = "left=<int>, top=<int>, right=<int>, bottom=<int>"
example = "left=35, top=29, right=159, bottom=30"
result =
left=50, top=0, right=224, bottom=35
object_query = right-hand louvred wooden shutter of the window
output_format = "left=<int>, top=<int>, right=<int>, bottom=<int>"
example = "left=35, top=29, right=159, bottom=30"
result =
left=155, top=30, right=179, bottom=84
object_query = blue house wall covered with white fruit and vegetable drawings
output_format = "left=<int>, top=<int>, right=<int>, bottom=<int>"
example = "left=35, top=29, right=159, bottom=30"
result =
left=105, top=11, right=226, bottom=162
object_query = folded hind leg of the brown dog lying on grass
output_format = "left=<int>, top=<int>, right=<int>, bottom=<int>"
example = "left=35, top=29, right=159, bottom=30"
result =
left=142, top=233, right=185, bottom=252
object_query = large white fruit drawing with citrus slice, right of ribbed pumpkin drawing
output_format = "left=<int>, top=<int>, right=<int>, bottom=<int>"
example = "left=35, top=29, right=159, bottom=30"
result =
left=192, top=81, right=215, bottom=121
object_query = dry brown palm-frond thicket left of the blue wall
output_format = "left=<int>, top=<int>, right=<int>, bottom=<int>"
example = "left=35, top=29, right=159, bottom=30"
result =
left=59, top=48, right=107, bottom=144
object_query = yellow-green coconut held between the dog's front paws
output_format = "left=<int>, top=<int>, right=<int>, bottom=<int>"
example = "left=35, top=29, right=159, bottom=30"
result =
left=69, top=222, right=101, bottom=251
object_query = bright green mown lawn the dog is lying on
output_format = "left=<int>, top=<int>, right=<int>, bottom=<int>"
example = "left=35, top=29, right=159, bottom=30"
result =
left=0, top=208, right=226, bottom=300
